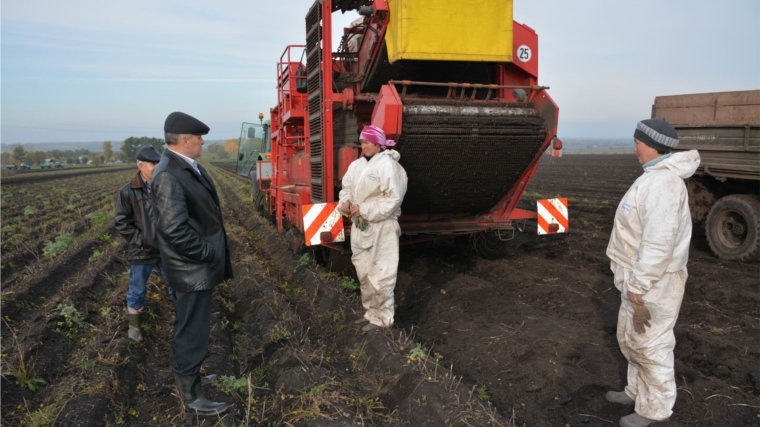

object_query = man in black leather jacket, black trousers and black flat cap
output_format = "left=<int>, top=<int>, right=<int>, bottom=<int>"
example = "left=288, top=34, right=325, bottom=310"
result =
left=152, top=112, right=232, bottom=415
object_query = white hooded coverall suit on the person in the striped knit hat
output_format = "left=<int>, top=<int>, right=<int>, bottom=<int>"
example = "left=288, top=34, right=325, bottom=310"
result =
left=607, top=150, right=699, bottom=421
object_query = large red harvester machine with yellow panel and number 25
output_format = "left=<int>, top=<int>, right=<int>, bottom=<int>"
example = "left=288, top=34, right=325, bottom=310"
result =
left=238, top=0, right=566, bottom=257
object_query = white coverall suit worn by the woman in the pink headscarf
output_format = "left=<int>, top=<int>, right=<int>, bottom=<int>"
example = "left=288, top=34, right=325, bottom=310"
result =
left=340, top=149, right=407, bottom=327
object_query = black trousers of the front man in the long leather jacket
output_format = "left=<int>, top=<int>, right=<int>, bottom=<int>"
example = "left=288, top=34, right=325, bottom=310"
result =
left=172, top=289, right=211, bottom=376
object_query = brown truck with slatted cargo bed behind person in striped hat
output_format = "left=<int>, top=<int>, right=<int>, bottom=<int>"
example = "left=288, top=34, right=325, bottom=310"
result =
left=652, top=90, right=760, bottom=261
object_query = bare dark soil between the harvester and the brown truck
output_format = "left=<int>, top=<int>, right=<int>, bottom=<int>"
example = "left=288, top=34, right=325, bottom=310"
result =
left=397, top=155, right=760, bottom=427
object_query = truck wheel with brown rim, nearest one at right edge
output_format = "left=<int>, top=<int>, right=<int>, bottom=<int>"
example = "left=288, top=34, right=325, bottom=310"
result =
left=705, top=194, right=760, bottom=262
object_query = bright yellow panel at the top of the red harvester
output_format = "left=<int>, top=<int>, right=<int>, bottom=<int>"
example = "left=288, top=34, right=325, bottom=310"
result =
left=385, top=0, right=512, bottom=62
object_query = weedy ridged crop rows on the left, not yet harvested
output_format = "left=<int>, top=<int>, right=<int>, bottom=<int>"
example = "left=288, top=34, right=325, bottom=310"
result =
left=2, top=166, right=508, bottom=427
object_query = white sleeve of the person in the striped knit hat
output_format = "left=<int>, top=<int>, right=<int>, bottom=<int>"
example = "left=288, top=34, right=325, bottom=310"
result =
left=627, top=175, right=683, bottom=295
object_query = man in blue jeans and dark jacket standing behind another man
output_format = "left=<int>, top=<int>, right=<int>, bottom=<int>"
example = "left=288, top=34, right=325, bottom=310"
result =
left=114, top=146, right=166, bottom=342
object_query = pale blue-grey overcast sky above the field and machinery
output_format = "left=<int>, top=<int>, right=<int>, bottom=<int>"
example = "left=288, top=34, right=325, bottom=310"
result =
left=0, top=0, right=760, bottom=144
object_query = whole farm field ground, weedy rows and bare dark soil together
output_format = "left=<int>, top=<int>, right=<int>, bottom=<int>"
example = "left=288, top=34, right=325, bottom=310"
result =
left=2, top=156, right=760, bottom=426
